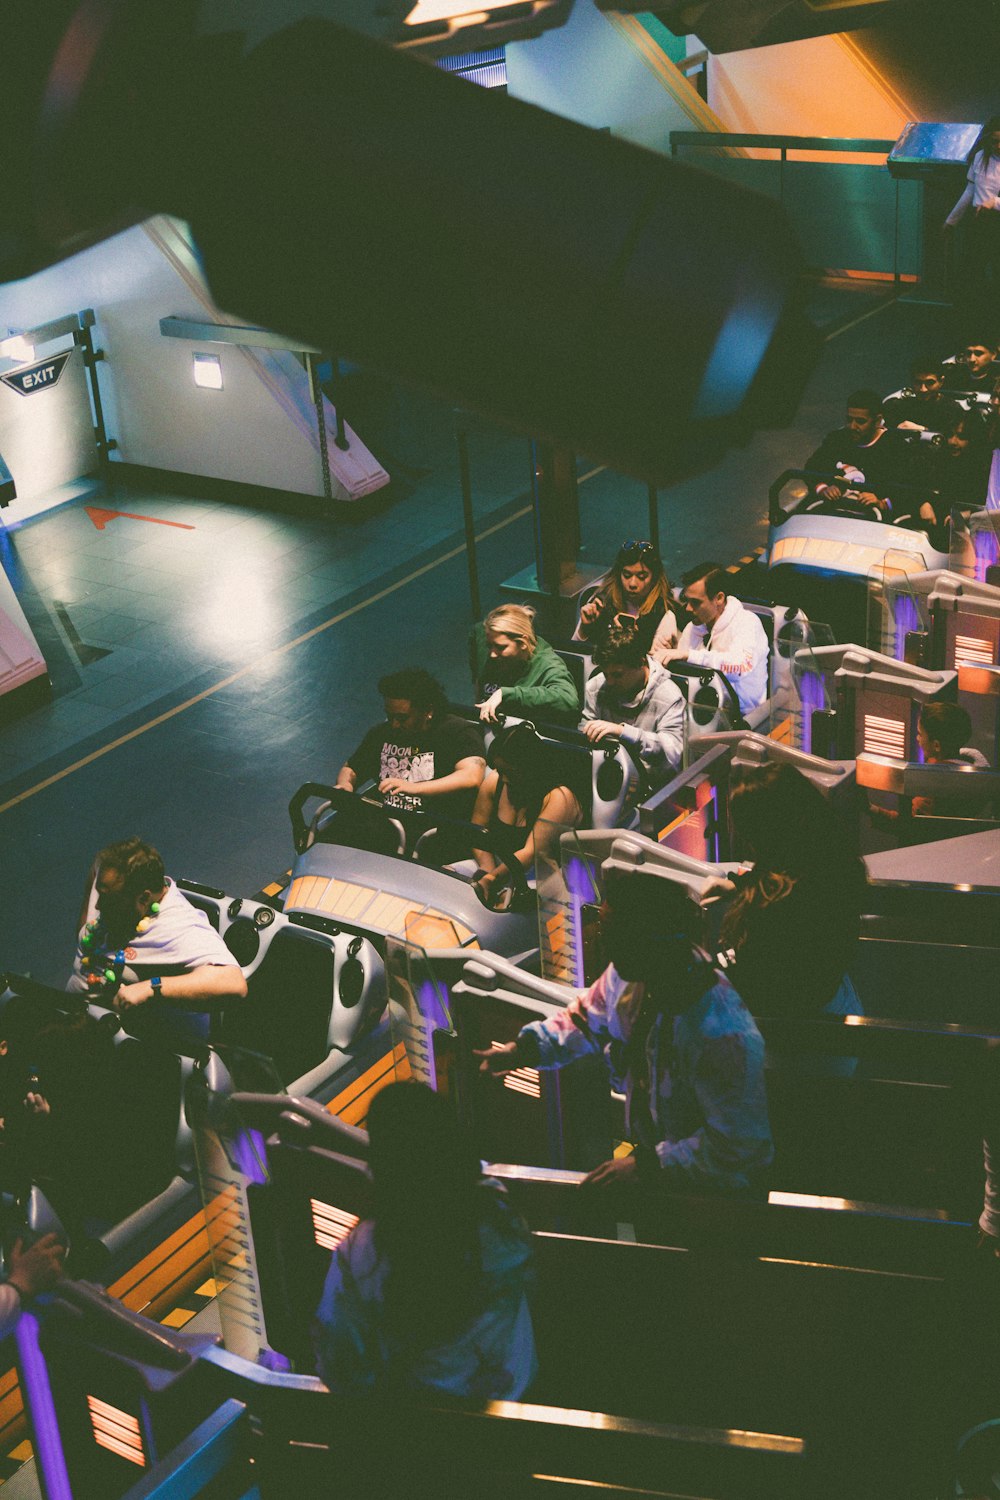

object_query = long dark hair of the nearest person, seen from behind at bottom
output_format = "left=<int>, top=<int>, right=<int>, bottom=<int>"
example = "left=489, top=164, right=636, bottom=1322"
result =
left=367, top=1082, right=487, bottom=1350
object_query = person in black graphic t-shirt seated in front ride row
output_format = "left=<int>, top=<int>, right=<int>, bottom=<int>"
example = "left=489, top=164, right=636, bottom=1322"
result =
left=336, top=668, right=486, bottom=822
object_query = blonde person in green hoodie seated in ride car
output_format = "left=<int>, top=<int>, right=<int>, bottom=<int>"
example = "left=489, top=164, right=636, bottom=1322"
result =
left=469, top=605, right=580, bottom=725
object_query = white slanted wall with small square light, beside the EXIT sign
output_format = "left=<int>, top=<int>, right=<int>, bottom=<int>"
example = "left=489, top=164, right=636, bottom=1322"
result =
left=0, top=218, right=388, bottom=500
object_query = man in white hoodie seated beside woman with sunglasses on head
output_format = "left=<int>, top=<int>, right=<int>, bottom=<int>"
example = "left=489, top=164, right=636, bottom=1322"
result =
left=661, top=563, right=769, bottom=714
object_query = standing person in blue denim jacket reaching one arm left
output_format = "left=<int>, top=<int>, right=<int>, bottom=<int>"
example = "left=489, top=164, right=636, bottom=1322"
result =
left=478, top=873, right=774, bottom=1193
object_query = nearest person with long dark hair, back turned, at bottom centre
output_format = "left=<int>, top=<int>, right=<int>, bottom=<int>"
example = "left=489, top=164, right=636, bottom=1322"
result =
left=313, top=1083, right=535, bottom=1401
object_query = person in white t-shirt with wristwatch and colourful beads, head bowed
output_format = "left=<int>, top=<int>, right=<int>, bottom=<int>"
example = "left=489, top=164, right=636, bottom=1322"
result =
left=66, top=839, right=246, bottom=1040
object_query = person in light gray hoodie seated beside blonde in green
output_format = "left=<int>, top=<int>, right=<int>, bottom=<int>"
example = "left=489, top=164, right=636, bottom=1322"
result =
left=580, top=626, right=685, bottom=789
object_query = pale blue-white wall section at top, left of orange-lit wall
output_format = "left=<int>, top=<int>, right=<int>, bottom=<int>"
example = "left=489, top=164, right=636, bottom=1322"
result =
left=507, top=0, right=710, bottom=152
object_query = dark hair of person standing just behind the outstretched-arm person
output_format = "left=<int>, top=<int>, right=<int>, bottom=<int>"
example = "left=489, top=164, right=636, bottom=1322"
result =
left=723, top=761, right=865, bottom=951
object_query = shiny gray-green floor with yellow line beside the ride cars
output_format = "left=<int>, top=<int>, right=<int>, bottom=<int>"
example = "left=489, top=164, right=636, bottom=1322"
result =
left=0, top=288, right=954, bottom=984
